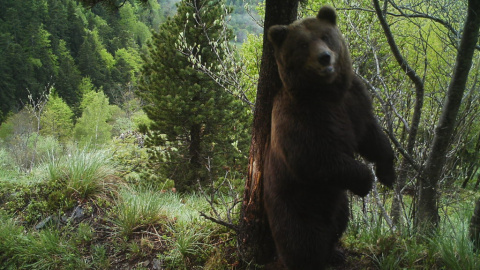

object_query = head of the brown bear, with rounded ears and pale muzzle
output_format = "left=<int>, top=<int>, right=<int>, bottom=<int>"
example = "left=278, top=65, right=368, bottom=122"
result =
left=268, top=6, right=353, bottom=97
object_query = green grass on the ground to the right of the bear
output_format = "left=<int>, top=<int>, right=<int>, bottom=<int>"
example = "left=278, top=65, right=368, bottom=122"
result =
left=344, top=193, right=480, bottom=270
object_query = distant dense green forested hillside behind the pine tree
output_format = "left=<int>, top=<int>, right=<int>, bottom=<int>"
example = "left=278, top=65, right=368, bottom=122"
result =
left=0, top=0, right=260, bottom=123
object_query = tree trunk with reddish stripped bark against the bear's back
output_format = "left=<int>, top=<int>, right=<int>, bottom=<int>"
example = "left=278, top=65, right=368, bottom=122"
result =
left=238, top=0, right=298, bottom=264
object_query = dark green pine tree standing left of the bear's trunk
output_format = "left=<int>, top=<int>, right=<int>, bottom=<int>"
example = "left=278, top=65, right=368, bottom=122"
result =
left=139, top=0, right=249, bottom=191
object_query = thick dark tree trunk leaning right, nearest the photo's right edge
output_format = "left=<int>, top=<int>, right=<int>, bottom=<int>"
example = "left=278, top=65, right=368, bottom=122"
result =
left=415, top=0, right=480, bottom=229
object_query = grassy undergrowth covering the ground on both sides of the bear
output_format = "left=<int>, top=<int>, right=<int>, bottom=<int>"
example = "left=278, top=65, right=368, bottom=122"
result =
left=0, top=144, right=480, bottom=270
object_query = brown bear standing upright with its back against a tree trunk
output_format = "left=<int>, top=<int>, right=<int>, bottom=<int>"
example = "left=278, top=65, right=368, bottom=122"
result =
left=264, top=7, right=395, bottom=270
